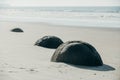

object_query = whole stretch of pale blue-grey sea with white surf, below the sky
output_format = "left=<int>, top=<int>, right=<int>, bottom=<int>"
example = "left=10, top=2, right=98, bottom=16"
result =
left=0, top=6, right=120, bottom=28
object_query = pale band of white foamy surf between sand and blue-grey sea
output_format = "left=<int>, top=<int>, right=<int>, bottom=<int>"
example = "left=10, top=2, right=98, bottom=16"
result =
left=0, top=12, right=120, bottom=28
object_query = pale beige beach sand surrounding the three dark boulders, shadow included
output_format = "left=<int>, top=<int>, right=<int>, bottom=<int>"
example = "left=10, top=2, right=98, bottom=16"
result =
left=0, top=22, right=120, bottom=80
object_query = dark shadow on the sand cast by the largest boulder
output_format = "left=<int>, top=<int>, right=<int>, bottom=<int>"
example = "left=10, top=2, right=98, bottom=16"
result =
left=68, top=64, right=115, bottom=71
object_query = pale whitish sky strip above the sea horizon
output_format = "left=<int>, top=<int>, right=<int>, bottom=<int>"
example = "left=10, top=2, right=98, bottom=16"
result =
left=0, top=0, right=120, bottom=6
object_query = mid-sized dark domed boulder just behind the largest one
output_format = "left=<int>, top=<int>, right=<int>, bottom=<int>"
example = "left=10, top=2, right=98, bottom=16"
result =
left=35, top=36, right=63, bottom=49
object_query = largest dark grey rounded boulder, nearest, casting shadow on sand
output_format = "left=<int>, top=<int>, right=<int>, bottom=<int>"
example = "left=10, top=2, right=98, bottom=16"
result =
left=51, top=41, right=103, bottom=66
